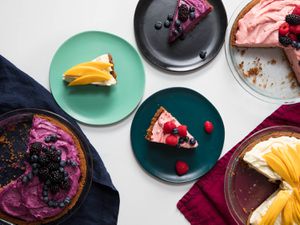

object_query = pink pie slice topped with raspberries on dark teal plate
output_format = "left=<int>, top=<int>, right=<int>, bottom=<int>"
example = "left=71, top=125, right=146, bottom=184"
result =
left=145, top=107, right=198, bottom=149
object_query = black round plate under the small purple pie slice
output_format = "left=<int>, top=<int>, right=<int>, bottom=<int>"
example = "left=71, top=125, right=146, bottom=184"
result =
left=134, top=0, right=227, bottom=72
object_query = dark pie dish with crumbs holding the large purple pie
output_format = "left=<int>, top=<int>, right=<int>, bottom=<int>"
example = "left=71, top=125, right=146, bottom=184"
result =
left=0, top=109, right=93, bottom=225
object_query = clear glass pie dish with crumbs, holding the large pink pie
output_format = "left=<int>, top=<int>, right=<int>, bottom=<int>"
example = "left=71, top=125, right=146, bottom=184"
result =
left=225, top=0, right=300, bottom=104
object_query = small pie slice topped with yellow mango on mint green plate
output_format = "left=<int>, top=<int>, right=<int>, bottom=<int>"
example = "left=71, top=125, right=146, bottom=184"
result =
left=63, top=54, right=117, bottom=86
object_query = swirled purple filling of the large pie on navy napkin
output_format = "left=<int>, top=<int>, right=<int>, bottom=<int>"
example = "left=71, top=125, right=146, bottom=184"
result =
left=0, top=116, right=81, bottom=221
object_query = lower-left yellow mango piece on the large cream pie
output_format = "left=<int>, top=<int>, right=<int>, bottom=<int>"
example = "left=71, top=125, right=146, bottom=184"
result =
left=259, top=190, right=291, bottom=225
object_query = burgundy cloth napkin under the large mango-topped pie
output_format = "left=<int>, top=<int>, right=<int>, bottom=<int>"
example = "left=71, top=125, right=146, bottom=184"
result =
left=177, top=103, right=300, bottom=225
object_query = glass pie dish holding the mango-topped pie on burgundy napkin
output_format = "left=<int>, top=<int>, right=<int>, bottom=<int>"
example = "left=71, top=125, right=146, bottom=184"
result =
left=224, top=126, right=300, bottom=225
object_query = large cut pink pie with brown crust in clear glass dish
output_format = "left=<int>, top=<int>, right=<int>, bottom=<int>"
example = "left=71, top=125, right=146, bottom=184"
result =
left=231, top=0, right=300, bottom=83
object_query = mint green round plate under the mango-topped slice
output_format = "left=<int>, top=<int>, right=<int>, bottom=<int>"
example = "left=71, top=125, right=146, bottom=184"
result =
left=50, top=31, right=145, bottom=125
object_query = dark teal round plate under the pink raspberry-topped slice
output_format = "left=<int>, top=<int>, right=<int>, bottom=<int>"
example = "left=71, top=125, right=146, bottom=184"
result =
left=131, top=87, right=224, bottom=183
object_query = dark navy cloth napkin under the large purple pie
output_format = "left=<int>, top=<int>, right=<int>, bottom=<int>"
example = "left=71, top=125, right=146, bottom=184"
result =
left=0, top=55, right=120, bottom=225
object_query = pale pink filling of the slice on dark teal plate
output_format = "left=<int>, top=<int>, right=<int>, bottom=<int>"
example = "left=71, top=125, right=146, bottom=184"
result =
left=151, top=111, right=198, bottom=148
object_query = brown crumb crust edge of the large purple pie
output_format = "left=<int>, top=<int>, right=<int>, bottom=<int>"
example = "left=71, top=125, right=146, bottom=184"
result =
left=0, top=114, right=87, bottom=225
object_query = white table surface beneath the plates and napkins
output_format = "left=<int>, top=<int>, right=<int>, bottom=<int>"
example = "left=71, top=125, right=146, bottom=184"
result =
left=0, top=0, right=278, bottom=225
